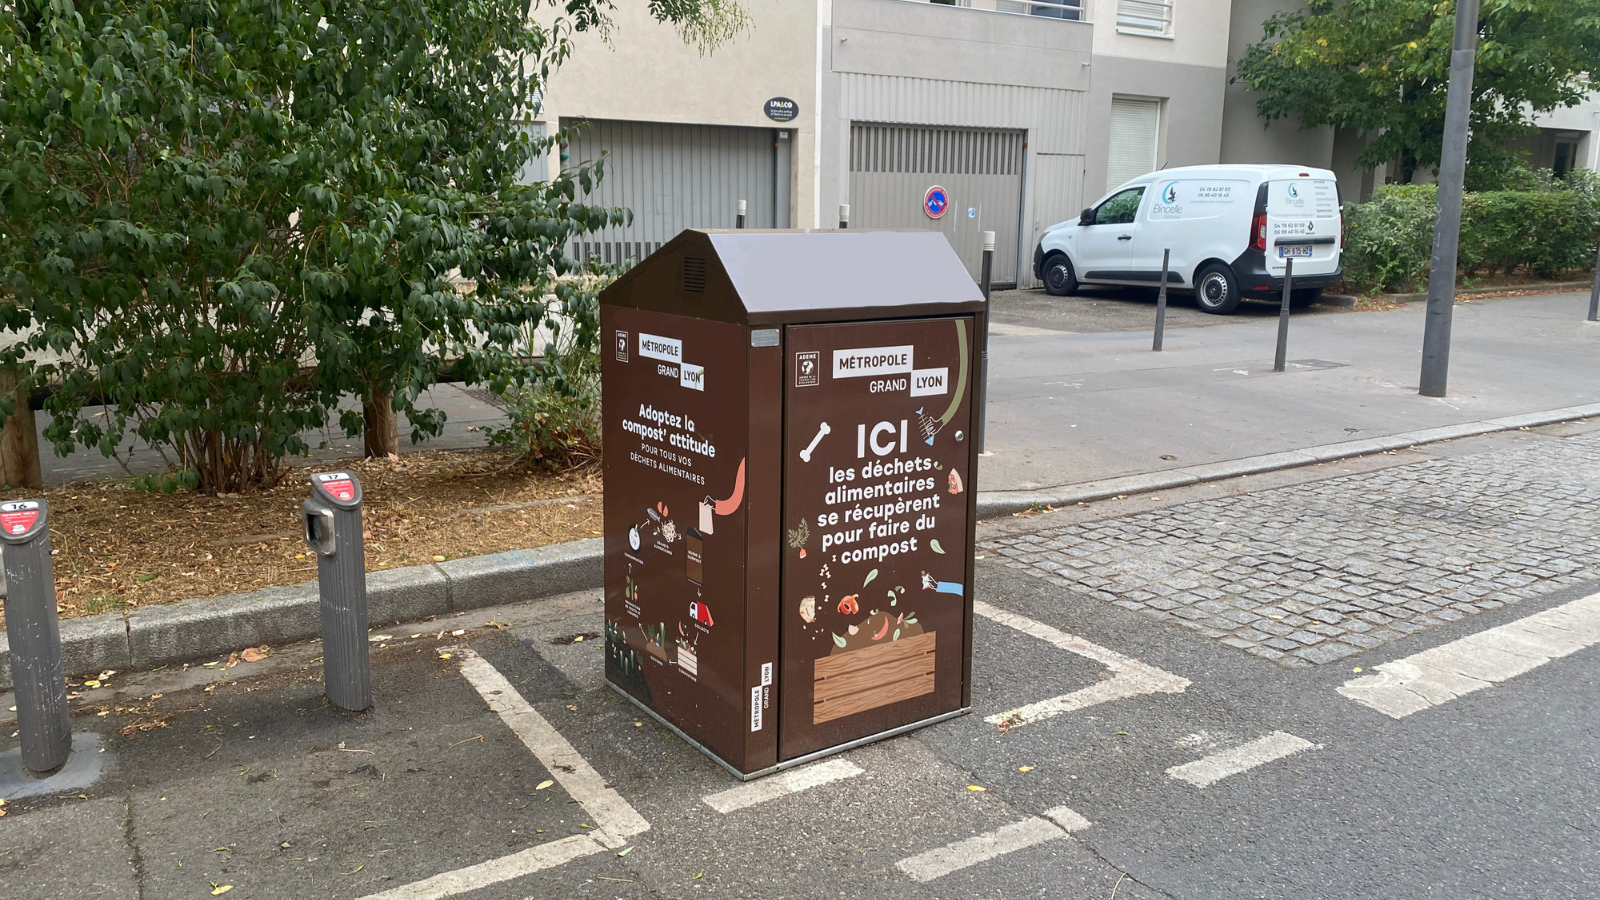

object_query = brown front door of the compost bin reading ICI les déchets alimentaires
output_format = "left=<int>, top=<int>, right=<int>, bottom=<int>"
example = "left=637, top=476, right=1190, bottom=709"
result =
left=778, top=315, right=976, bottom=759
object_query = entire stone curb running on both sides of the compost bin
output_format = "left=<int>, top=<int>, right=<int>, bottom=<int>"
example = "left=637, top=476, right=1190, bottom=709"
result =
left=0, top=404, right=1600, bottom=690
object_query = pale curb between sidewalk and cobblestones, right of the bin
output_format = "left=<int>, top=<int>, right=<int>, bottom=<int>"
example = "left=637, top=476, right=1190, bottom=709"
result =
left=978, top=404, right=1600, bottom=519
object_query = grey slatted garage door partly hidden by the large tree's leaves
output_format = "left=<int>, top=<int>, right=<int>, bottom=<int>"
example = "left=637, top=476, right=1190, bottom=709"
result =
left=562, top=119, right=790, bottom=263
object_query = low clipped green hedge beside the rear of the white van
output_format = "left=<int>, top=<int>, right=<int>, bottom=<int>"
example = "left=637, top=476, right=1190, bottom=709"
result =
left=1344, top=170, right=1600, bottom=291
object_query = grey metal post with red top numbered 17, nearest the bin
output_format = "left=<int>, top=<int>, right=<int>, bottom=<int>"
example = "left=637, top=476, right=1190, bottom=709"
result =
left=301, top=472, right=373, bottom=713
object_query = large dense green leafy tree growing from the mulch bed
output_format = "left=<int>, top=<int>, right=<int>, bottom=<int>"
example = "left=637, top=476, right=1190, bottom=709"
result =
left=0, top=0, right=742, bottom=492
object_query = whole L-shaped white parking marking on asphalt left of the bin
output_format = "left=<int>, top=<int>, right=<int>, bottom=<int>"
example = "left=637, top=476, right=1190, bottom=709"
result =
left=362, top=647, right=650, bottom=900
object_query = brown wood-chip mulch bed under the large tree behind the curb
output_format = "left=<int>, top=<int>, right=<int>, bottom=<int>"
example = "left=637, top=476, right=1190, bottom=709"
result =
left=0, top=450, right=600, bottom=617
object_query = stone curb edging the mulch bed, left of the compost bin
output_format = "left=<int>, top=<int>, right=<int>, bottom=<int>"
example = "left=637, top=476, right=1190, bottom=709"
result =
left=0, top=538, right=603, bottom=690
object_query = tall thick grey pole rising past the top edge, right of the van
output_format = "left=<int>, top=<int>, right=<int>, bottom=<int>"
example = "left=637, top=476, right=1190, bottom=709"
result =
left=1419, top=0, right=1478, bottom=397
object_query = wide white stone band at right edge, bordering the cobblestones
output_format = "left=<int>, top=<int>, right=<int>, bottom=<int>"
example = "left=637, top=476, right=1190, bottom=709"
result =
left=1339, top=594, right=1600, bottom=719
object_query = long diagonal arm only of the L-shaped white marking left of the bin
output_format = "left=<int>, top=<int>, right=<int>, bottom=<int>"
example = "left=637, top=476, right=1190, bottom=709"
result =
left=453, top=647, right=650, bottom=849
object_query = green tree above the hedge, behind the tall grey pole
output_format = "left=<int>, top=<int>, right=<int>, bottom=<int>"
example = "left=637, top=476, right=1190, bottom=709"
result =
left=1237, top=0, right=1600, bottom=181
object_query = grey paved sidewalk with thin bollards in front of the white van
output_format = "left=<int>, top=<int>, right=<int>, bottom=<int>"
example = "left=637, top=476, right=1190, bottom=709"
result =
left=978, top=291, right=1600, bottom=492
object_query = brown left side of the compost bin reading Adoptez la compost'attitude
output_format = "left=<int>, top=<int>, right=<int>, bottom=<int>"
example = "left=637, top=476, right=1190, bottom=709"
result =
left=600, top=306, right=750, bottom=767
